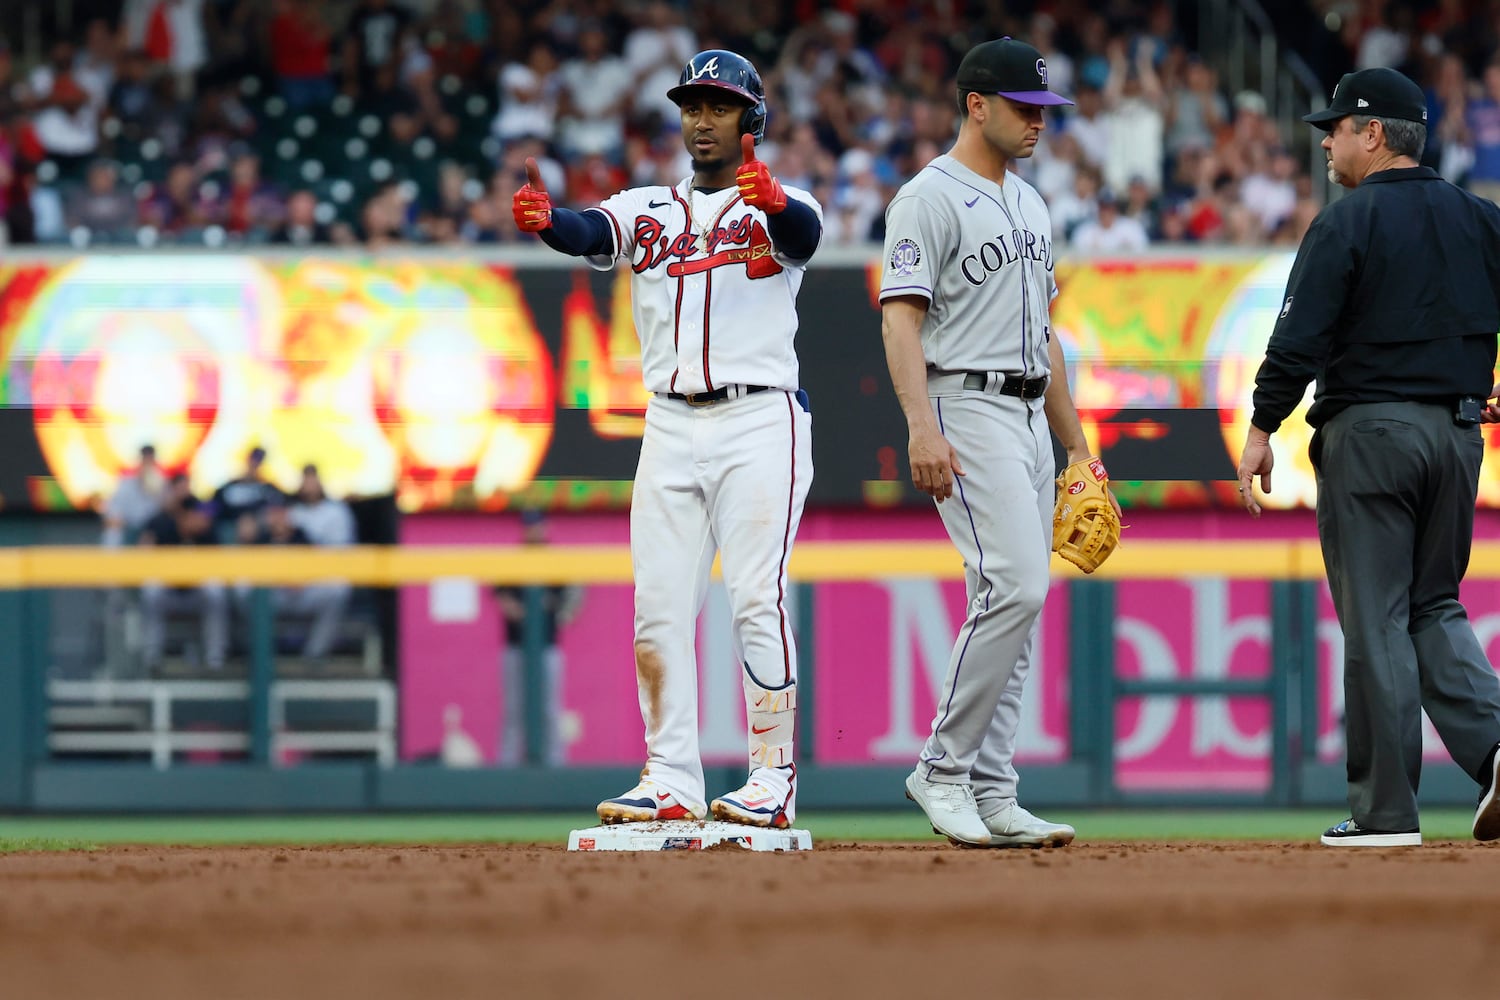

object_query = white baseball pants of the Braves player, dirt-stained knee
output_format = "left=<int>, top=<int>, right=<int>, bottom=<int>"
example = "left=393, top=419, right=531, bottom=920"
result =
left=630, top=390, right=813, bottom=814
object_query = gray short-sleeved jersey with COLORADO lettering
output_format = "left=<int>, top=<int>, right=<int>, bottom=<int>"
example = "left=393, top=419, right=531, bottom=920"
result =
left=881, top=156, right=1058, bottom=378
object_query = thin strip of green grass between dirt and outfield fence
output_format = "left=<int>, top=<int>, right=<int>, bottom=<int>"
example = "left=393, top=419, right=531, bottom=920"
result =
left=0, top=807, right=1472, bottom=853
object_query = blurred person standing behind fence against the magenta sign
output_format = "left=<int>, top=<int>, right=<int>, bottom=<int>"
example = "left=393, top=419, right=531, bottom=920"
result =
left=495, top=510, right=584, bottom=765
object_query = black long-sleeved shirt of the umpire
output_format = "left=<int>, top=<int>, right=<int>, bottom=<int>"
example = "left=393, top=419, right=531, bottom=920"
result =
left=1251, top=166, right=1500, bottom=433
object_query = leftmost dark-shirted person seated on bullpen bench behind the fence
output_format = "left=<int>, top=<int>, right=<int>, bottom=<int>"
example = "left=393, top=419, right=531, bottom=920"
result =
left=140, top=472, right=230, bottom=672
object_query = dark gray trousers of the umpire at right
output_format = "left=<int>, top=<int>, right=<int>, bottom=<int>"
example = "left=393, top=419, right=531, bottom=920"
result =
left=1313, top=403, right=1500, bottom=831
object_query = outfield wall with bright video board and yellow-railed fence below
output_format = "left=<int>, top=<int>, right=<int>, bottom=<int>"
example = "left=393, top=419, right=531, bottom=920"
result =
left=0, top=247, right=1500, bottom=811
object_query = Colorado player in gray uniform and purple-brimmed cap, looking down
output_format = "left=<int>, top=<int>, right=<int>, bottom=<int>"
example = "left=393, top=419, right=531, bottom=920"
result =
left=881, top=37, right=1113, bottom=847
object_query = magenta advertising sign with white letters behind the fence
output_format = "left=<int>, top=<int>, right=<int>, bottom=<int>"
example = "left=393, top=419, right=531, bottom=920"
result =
left=401, top=511, right=1500, bottom=792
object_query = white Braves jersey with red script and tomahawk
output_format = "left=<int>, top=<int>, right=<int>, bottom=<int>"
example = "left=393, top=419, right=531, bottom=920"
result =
left=587, top=180, right=824, bottom=393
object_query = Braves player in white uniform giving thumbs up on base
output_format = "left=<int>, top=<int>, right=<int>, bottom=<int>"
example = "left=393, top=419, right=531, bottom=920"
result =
left=513, top=49, right=822, bottom=828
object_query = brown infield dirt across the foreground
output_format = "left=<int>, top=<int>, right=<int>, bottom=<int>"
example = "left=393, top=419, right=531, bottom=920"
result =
left=0, top=843, right=1500, bottom=1000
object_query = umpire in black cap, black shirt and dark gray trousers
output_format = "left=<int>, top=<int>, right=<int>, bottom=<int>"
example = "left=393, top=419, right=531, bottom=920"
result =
left=1239, top=69, right=1500, bottom=847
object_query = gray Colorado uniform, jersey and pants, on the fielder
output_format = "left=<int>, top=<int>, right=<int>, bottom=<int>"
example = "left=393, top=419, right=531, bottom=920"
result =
left=881, top=156, right=1058, bottom=816
